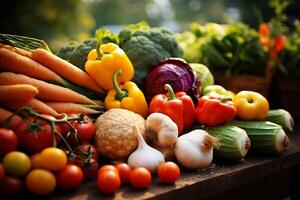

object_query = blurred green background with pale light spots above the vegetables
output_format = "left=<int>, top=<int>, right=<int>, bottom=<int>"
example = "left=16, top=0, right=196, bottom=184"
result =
left=0, top=0, right=300, bottom=50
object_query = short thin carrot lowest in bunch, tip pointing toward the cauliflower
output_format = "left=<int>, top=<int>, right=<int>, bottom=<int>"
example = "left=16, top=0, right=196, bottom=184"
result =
left=46, top=102, right=100, bottom=115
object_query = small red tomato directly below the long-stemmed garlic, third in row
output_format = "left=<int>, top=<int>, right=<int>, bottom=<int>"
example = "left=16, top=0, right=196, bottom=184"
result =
left=130, top=167, right=152, bottom=189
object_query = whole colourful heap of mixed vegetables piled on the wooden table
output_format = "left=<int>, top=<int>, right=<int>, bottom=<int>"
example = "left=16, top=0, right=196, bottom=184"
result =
left=0, top=19, right=294, bottom=198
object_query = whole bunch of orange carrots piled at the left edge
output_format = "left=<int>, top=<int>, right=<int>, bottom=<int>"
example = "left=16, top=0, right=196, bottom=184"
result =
left=0, top=44, right=104, bottom=128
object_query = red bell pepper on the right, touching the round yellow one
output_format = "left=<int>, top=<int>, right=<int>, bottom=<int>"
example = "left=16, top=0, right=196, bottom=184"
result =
left=196, top=96, right=237, bottom=126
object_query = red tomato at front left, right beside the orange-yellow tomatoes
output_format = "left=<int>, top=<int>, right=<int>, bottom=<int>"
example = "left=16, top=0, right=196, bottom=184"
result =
left=56, top=164, right=83, bottom=190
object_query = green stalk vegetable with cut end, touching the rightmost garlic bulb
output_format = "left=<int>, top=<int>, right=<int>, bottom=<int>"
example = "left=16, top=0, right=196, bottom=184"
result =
left=207, top=125, right=251, bottom=160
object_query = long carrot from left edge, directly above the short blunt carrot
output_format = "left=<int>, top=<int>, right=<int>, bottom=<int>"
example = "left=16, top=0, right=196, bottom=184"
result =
left=0, top=72, right=95, bottom=104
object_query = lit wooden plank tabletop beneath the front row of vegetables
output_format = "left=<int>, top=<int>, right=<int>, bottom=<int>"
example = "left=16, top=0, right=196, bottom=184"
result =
left=41, top=131, right=300, bottom=200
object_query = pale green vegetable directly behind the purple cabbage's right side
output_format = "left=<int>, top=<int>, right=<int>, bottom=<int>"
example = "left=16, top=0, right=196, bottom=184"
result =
left=190, top=63, right=214, bottom=94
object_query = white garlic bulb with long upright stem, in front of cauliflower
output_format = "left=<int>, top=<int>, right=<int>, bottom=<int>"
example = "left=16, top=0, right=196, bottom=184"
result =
left=127, top=126, right=165, bottom=173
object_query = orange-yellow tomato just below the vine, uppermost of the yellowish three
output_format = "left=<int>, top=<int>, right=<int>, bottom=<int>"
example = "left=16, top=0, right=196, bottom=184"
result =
left=40, top=147, right=68, bottom=171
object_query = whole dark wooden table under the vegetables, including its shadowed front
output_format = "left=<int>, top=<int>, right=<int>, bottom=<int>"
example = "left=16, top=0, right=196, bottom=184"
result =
left=45, top=128, right=300, bottom=200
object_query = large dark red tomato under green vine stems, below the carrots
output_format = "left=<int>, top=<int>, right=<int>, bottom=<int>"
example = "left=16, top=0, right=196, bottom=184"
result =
left=16, top=116, right=61, bottom=153
